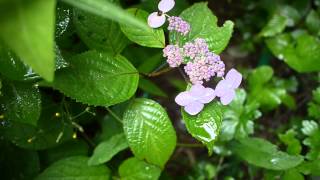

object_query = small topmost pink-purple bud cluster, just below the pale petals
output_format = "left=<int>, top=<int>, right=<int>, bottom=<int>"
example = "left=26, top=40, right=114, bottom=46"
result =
left=168, top=16, right=190, bottom=36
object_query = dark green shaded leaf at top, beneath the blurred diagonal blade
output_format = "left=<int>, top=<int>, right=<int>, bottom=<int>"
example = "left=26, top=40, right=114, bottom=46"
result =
left=73, top=0, right=128, bottom=54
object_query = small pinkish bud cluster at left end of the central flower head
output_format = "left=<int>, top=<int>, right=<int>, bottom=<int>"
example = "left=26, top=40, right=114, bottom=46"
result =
left=163, top=45, right=183, bottom=67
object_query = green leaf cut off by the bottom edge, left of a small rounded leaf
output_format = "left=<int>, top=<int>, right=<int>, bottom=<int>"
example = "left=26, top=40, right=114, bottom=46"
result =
left=36, top=156, right=111, bottom=180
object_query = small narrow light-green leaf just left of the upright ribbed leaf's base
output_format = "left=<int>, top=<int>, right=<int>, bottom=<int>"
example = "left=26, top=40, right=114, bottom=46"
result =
left=88, top=134, right=128, bottom=166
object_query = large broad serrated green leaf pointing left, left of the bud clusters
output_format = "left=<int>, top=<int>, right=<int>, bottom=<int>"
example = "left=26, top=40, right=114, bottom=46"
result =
left=52, top=51, right=139, bottom=106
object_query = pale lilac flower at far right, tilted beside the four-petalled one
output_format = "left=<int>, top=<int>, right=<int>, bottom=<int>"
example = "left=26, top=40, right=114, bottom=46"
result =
left=215, top=69, right=242, bottom=105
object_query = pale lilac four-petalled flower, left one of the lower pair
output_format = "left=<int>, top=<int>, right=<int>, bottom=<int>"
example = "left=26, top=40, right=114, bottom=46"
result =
left=175, top=84, right=215, bottom=115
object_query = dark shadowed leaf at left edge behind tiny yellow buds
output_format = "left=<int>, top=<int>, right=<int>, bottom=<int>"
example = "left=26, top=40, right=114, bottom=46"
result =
left=0, top=97, right=73, bottom=150
